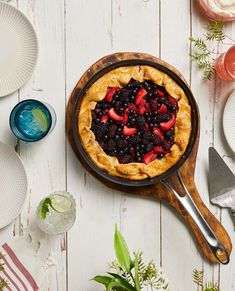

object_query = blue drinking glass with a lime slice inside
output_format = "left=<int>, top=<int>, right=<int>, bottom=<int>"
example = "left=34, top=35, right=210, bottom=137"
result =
left=9, top=99, right=56, bottom=142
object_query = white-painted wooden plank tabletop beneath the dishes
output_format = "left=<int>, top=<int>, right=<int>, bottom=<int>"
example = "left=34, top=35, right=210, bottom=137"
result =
left=0, top=0, right=235, bottom=291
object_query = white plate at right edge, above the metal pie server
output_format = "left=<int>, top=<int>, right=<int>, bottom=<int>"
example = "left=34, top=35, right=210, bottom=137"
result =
left=223, top=90, right=235, bottom=153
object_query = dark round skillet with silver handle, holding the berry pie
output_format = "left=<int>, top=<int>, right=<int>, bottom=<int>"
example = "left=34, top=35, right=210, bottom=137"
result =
left=73, top=59, right=229, bottom=264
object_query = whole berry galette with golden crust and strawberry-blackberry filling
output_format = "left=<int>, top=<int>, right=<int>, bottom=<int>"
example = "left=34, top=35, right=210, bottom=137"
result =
left=78, top=66, right=192, bottom=180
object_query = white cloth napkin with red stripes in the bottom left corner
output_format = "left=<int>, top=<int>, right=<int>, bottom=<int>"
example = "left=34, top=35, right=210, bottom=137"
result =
left=0, top=226, right=56, bottom=291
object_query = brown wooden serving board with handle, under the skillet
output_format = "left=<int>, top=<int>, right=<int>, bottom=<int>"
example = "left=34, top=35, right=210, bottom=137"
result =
left=66, top=53, right=232, bottom=263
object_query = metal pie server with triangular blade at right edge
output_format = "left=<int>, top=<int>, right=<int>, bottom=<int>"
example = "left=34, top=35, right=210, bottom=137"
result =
left=209, top=147, right=235, bottom=229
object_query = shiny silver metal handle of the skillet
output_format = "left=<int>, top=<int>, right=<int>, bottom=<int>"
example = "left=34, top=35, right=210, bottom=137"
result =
left=162, top=172, right=229, bottom=265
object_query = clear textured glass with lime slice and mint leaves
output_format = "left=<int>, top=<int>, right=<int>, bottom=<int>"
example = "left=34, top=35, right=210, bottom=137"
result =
left=36, top=191, right=76, bottom=234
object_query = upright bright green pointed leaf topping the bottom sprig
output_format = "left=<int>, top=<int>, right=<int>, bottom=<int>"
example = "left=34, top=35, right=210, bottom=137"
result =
left=114, top=225, right=131, bottom=273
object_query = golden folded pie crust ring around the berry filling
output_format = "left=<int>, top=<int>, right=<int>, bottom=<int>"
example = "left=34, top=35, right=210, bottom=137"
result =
left=78, top=66, right=192, bottom=180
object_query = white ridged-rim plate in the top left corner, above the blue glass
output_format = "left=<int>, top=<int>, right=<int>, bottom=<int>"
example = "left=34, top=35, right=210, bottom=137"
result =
left=0, top=2, right=38, bottom=97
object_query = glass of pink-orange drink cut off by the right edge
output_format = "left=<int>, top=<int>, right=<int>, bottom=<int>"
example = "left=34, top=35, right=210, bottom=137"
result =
left=215, top=45, right=235, bottom=81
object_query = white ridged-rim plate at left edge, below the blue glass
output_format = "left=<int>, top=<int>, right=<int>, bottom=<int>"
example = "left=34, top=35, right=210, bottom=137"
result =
left=0, top=142, right=27, bottom=229
